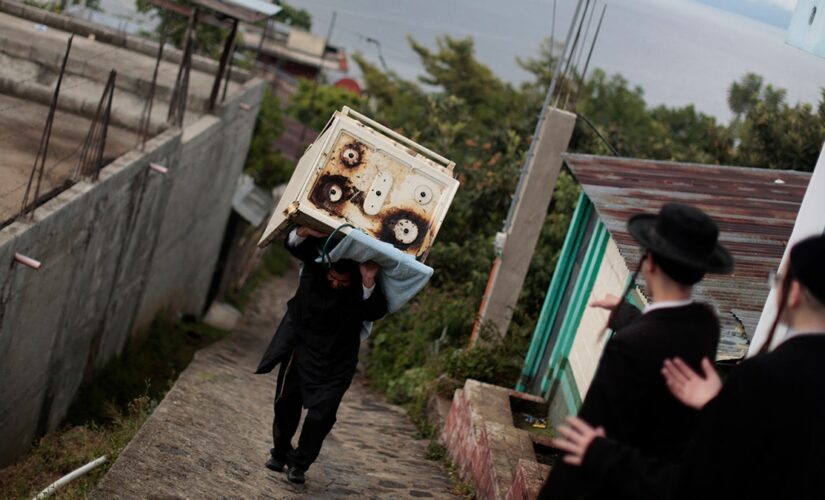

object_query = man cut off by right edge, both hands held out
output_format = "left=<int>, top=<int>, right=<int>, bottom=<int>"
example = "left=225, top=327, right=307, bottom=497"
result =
left=555, top=236, right=825, bottom=500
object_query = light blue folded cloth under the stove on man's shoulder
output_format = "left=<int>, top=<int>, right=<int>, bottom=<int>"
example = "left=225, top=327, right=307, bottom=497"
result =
left=318, top=230, right=433, bottom=339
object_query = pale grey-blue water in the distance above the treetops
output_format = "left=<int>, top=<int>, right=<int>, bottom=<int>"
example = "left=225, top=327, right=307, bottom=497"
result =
left=290, top=0, right=825, bottom=121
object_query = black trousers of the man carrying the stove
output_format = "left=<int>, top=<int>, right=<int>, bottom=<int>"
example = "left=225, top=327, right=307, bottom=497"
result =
left=270, top=363, right=345, bottom=471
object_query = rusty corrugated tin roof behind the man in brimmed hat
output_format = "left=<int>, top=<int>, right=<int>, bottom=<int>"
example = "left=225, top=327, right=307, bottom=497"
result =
left=565, top=154, right=811, bottom=361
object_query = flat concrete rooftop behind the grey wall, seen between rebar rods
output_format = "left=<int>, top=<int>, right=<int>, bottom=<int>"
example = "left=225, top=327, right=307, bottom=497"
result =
left=0, top=0, right=248, bottom=226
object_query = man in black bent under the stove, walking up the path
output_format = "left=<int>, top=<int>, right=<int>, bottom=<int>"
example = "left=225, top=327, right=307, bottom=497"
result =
left=255, top=227, right=387, bottom=483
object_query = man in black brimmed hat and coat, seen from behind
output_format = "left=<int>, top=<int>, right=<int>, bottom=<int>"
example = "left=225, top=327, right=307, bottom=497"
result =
left=539, top=204, right=733, bottom=500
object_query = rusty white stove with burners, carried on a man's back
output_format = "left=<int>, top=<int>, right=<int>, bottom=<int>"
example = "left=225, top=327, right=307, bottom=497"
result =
left=258, top=107, right=458, bottom=261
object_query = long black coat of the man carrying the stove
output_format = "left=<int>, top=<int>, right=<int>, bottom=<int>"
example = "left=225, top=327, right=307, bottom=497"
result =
left=255, top=233, right=387, bottom=408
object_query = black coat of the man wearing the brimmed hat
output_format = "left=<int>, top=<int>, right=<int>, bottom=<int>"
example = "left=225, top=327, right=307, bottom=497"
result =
left=539, top=303, right=719, bottom=500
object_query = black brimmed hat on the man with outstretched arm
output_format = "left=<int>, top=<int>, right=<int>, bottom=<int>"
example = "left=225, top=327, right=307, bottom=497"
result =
left=627, top=203, right=733, bottom=274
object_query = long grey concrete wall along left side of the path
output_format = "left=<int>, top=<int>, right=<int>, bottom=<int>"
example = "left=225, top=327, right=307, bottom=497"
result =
left=0, top=76, right=264, bottom=466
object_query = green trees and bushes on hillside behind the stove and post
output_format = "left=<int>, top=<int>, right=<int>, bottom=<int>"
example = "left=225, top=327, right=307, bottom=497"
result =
left=290, top=33, right=825, bottom=428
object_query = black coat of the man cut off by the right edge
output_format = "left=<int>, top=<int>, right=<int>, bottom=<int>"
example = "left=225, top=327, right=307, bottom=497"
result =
left=583, top=332, right=825, bottom=500
